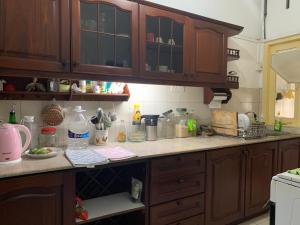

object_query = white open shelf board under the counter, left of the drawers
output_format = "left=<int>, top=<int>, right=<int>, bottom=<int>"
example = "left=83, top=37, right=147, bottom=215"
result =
left=76, top=192, right=145, bottom=224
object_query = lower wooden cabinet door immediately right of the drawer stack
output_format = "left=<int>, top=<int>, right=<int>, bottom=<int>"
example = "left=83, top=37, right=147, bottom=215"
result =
left=206, top=147, right=245, bottom=225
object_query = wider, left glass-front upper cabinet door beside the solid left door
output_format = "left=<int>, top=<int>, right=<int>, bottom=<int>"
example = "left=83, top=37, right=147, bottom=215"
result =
left=72, top=0, right=138, bottom=76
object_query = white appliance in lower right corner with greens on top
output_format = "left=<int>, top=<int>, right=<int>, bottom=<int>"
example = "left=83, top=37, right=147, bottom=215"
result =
left=270, top=172, right=300, bottom=225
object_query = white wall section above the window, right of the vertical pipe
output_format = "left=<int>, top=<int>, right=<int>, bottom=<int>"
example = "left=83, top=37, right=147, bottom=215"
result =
left=266, top=0, right=300, bottom=40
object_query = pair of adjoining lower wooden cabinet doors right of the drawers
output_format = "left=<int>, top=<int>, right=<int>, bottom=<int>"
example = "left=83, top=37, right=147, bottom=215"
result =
left=206, top=142, right=278, bottom=225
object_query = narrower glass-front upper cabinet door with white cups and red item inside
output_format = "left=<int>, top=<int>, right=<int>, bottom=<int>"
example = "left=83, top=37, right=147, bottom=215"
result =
left=140, top=6, right=187, bottom=80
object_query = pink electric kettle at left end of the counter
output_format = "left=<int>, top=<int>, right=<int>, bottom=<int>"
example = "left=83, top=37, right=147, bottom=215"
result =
left=0, top=123, right=31, bottom=164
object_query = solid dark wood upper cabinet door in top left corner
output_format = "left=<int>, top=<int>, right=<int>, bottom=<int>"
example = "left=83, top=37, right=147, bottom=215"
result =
left=0, top=0, right=70, bottom=72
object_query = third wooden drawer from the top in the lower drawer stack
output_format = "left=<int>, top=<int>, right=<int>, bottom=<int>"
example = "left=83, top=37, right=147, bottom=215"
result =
left=150, top=194, right=204, bottom=225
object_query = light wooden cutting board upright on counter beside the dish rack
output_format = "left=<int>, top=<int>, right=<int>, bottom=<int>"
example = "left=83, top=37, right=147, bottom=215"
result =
left=211, top=110, right=238, bottom=136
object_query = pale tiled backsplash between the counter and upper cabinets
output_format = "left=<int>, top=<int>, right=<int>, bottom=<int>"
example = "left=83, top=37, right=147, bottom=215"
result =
left=0, top=84, right=260, bottom=145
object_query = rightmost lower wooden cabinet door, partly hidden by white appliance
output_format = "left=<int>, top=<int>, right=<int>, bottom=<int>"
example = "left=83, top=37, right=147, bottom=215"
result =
left=278, top=139, right=300, bottom=173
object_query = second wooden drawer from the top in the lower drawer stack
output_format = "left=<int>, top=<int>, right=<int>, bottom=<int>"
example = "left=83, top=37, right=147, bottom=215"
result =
left=150, top=173, right=205, bottom=205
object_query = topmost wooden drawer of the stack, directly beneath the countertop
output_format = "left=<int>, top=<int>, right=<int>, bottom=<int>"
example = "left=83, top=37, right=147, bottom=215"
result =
left=151, top=153, right=205, bottom=180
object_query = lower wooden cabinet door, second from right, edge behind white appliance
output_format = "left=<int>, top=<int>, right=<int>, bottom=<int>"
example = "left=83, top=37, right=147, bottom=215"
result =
left=245, top=142, right=277, bottom=216
